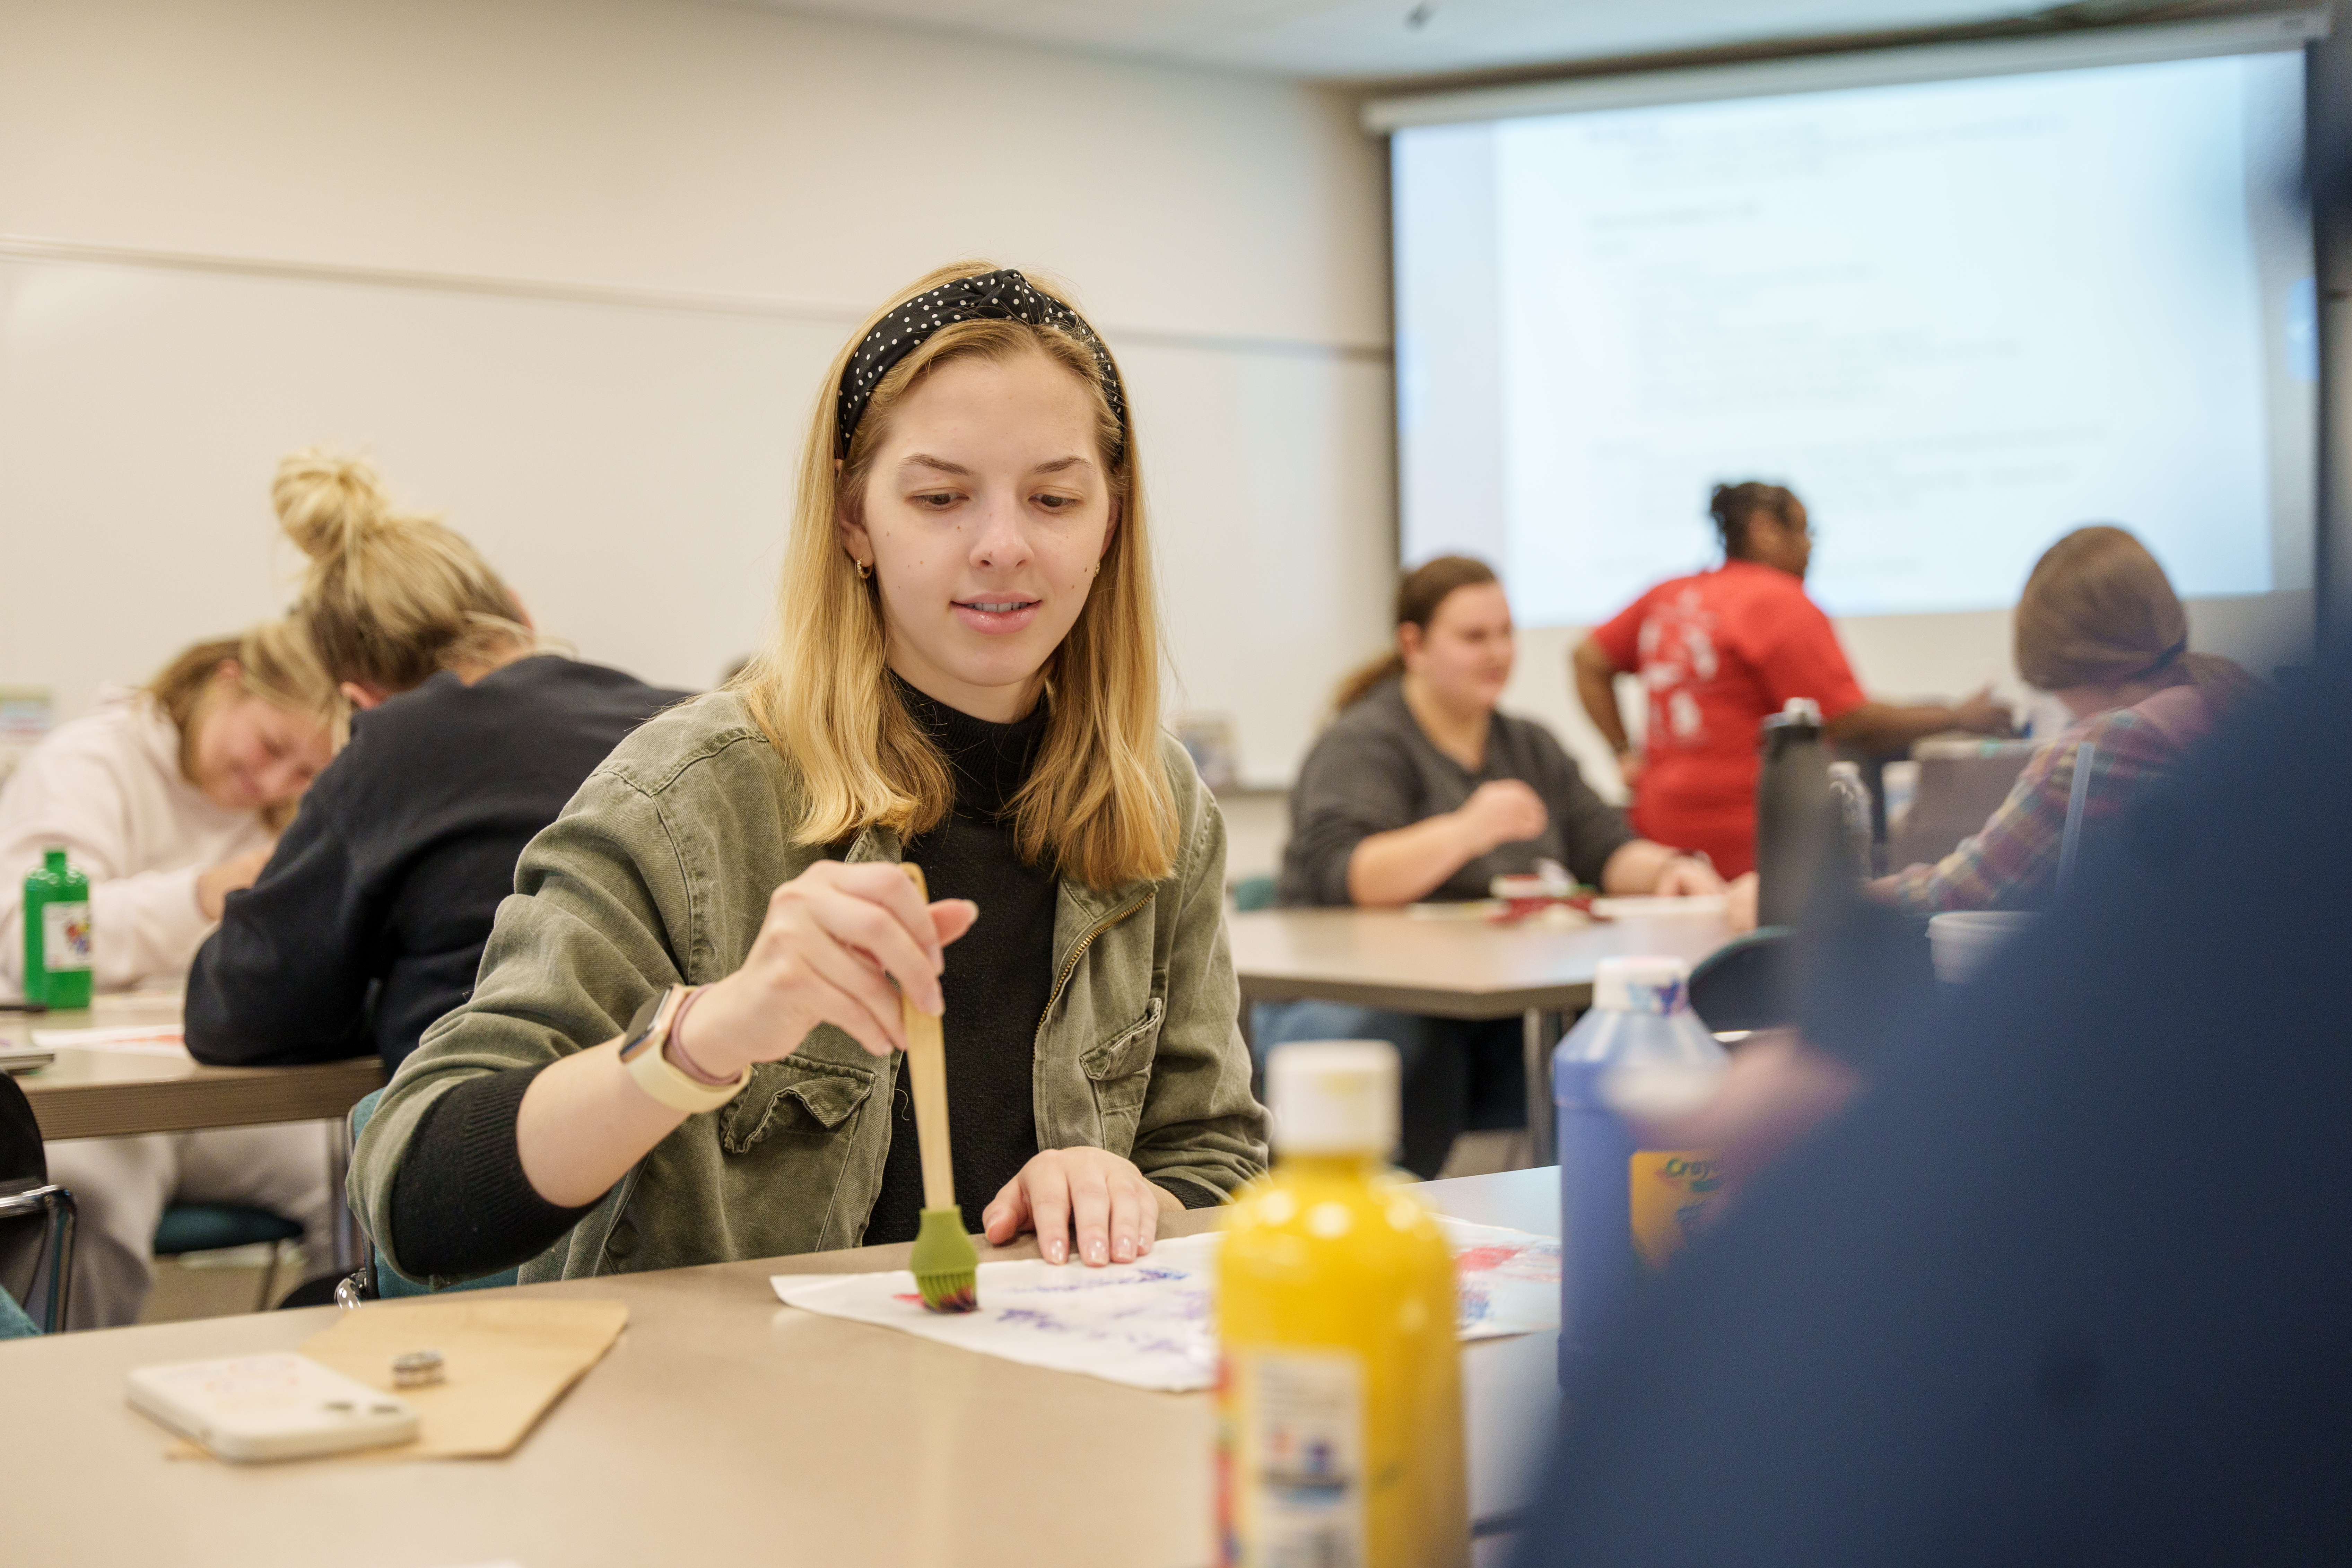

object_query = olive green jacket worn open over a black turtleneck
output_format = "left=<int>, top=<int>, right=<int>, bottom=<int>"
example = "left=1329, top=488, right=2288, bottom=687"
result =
left=350, top=694, right=1265, bottom=1283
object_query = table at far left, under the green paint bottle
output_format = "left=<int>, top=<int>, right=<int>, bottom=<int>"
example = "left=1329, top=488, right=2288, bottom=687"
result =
left=0, top=992, right=383, bottom=1270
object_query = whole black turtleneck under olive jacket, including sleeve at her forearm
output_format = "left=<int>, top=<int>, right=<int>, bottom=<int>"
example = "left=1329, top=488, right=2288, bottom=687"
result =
left=393, top=677, right=1063, bottom=1277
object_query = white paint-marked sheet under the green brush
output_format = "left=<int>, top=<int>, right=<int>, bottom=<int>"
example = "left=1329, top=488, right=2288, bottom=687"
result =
left=769, top=1220, right=1559, bottom=1392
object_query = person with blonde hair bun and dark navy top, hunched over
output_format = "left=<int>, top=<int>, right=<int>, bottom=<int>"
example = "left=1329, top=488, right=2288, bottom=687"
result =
left=186, top=449, right=687, bottom=1067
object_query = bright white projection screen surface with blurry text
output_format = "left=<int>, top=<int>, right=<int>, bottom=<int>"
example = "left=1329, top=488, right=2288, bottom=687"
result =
left=1395, top=54, right=2317, bottom=625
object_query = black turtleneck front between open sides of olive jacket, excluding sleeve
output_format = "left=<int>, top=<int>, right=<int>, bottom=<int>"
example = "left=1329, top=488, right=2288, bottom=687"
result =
left=865, top=682, right=1054, bottom=1244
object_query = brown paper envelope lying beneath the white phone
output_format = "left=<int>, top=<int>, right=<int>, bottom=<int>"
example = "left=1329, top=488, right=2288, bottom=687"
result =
left=301, top=1295, right=628, bottom=1460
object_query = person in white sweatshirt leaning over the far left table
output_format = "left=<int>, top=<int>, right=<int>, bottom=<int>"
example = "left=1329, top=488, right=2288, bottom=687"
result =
left=0, top=621, right=341, bottom=1328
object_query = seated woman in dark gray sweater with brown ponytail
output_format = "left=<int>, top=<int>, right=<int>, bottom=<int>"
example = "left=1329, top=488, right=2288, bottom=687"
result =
left=1279, top=555, right=1724, bottom=1175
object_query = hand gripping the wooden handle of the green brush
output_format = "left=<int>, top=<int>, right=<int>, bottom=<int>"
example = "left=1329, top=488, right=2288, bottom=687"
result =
left=677, top=860, right=981, bottom=1079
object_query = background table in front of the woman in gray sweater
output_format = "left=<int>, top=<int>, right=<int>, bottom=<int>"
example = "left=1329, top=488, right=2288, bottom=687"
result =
left=1226, top=910, right=1731, bottom=1159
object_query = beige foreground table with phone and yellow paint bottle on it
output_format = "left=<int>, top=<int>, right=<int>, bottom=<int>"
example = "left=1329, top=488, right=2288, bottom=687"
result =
left=0, top=1171, right=1559, bottom=1568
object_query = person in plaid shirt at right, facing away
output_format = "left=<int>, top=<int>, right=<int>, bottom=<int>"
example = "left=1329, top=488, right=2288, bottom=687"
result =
left=1872, top=526, right=2256, bottom=914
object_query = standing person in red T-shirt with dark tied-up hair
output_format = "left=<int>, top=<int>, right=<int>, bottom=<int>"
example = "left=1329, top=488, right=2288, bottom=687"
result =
left=1574, top=480, right=2009, bottom=877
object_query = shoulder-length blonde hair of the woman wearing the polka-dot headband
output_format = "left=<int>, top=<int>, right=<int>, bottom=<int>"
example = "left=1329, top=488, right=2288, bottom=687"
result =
left=731, top=261, right=1176, bottom=889
